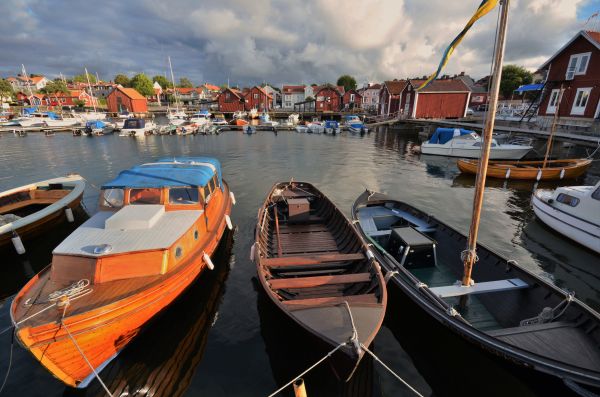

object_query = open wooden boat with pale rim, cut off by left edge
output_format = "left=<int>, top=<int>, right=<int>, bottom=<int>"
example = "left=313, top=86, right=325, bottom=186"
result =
left=0, top=174, right=85, bottom=253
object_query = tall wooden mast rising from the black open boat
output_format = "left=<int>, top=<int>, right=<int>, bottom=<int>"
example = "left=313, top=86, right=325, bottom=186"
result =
left=461, top=0, right=510, bottom=286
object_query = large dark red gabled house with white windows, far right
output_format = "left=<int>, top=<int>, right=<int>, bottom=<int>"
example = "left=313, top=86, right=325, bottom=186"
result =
left=537, top=30, right=600, bottom=127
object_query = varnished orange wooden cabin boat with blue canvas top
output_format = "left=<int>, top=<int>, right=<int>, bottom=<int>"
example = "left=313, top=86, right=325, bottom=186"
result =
left=11, top=157, right=234, bottom=386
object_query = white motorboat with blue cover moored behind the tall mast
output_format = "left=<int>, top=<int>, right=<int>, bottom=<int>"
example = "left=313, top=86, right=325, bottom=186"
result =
left=421, top=128, right=533, bottom=160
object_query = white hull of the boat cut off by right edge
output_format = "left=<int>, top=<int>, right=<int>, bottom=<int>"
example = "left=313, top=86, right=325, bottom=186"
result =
left=531, top=194, right=600, bottom=253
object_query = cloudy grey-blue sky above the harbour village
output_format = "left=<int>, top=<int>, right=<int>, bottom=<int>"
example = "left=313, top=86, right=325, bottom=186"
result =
left=0, top=0, right=600, bottom=85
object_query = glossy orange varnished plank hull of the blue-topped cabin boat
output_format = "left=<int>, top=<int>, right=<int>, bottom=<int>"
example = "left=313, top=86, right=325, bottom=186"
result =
left=11, top=182, right=232, bottom=387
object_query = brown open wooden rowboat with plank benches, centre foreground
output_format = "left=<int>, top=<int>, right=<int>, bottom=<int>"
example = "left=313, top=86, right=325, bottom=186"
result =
left=253, top=182, right=387, bottom=381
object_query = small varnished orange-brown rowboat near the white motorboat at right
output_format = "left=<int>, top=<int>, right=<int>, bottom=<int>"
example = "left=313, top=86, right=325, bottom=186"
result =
left=457, top=159, right=592, bottom=181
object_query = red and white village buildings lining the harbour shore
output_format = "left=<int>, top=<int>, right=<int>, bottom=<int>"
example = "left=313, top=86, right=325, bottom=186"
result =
left=0, top=30, right=600, bottom=133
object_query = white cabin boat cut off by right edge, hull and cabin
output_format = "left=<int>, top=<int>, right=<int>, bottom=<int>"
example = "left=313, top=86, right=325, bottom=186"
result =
left=531, top=182, right=600, bottom=254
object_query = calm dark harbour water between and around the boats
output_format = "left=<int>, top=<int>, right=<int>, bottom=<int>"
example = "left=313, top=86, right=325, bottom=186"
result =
left=0, top=129, right=600, bottom=397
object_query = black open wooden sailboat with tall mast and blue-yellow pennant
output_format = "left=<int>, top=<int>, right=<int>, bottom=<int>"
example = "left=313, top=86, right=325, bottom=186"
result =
left=352, top=0, right=600, bottom=395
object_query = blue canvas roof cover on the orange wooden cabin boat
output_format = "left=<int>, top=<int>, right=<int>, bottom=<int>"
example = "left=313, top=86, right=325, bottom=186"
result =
left=102, top=157, right=222, bottom=189
